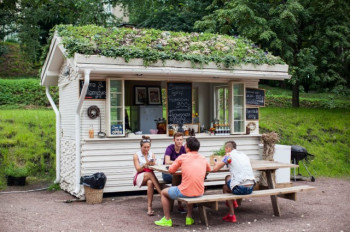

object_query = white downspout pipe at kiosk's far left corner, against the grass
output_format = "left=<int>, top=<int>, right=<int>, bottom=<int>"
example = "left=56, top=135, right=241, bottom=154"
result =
left=46, top=86, right=61, bottom=184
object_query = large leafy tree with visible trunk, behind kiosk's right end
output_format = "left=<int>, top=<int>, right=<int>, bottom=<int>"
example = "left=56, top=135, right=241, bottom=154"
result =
left=195, top=0, right=350, bottom=107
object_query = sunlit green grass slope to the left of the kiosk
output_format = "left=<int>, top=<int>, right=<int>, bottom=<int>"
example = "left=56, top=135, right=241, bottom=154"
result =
left=0, top=110, right=56, bottom=188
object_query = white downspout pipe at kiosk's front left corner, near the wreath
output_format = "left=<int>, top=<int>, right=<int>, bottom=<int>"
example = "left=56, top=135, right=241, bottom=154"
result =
left=74, top=69, right=91, bottom=194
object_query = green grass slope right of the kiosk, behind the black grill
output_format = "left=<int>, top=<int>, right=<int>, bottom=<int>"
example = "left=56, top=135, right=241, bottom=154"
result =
left=259, top=108, right=350, bottom=177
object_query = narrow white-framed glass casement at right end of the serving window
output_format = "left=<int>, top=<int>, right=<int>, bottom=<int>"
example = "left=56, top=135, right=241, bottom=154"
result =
left=230, top=82, right=245, bottom=134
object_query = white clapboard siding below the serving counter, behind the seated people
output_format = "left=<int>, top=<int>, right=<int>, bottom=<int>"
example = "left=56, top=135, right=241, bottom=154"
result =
left=81, top=135, right=260, bottom=192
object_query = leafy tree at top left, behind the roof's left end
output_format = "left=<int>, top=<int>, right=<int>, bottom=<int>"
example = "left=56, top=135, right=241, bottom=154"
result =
left=3, top=0, right=118, bottom=62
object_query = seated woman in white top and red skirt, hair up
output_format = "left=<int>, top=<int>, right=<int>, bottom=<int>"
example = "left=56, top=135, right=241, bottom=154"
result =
left=133, top=136, right=162, bottom=216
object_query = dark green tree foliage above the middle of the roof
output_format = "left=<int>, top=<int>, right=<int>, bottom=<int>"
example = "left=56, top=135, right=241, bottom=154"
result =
left=116, top=0, right=211, bottom=32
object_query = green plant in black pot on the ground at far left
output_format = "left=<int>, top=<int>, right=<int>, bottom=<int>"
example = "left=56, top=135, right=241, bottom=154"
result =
left=5, top=163, right=28, bottom=186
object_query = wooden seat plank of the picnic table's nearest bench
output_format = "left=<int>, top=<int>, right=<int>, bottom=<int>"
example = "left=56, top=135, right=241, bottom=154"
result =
left=178, top=185, right=315, bottom=204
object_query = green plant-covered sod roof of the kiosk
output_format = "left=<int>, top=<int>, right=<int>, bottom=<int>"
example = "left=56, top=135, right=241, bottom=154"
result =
left=56, top=25, right=285, bottom=68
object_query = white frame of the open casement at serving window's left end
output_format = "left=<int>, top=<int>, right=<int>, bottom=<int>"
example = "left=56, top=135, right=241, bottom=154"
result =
left=106, top=78, right=125, bottom=137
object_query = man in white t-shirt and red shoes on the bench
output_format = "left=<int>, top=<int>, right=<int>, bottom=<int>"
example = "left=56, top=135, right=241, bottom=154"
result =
left=213, top=141, right=255, bottom=222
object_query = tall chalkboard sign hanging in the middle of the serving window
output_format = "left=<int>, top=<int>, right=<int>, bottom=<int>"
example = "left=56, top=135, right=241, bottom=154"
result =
left=167, top=82, right=192, bottom=124
